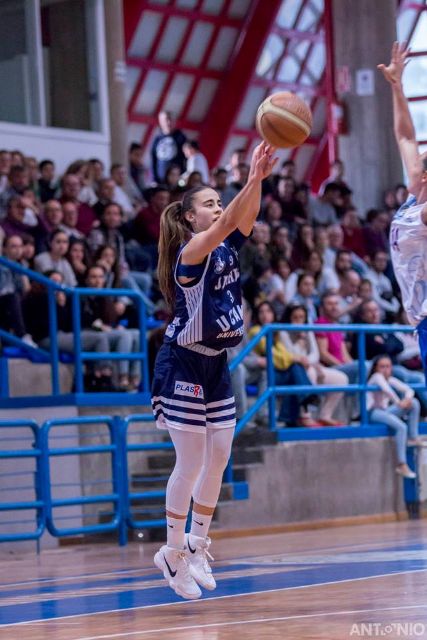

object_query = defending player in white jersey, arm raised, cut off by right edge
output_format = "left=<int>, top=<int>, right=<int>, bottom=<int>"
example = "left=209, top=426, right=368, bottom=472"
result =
left=378, top=42, right=427, bottom=381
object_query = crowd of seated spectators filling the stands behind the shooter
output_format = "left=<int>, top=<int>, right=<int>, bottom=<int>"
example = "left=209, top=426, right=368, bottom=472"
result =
left=0, top=112, right=427, bottom=416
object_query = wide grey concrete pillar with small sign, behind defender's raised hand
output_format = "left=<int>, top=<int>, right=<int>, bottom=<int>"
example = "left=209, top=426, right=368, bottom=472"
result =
left=332, top=0, right=403, bottom=212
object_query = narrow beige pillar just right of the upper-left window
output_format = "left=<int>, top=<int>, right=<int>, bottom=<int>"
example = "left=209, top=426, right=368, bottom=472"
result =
left=104, top=0, right=127, bottom=164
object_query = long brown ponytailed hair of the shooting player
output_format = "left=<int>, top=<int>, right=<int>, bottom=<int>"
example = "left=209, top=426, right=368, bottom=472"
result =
left=157, top=186, right=207, bottom=309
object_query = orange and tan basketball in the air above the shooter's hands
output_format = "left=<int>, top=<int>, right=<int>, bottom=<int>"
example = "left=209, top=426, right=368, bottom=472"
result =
left=256, top=91, right=313, bottom=148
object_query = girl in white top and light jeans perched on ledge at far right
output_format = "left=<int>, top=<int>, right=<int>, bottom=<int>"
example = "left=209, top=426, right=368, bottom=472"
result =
left=367, top=355, right=422, bottom=478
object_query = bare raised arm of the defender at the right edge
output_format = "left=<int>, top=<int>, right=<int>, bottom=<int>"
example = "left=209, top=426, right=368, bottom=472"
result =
left=378, top=42, right=423, bottom=196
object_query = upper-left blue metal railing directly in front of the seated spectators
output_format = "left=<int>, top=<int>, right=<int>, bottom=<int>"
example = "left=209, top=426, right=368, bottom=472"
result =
left=0, top=256, right=150, bottom=398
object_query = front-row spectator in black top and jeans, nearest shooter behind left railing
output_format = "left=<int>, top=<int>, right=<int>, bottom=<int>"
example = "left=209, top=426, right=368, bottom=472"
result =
left=82, top=265, right=141, bottom=391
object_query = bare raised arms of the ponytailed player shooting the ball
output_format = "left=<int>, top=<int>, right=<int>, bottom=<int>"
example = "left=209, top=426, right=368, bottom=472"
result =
left=182, top=143, right=276, bottom=265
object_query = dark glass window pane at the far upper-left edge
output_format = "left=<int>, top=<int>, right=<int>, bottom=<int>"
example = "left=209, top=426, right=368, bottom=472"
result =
left=0, top=0, right=40, bottom=124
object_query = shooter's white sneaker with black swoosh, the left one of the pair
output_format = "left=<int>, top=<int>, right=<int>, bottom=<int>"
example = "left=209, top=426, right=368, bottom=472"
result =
left=154, top=545, right=202, bottom=600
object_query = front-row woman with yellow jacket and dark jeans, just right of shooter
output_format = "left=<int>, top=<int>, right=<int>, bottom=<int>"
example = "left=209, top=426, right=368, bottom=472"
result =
left=248, top=302, right=317, bottom=427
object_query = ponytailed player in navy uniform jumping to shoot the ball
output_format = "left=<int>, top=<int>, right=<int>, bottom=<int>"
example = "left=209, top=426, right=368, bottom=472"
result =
left=152, top=142, right=276, bottom=599
